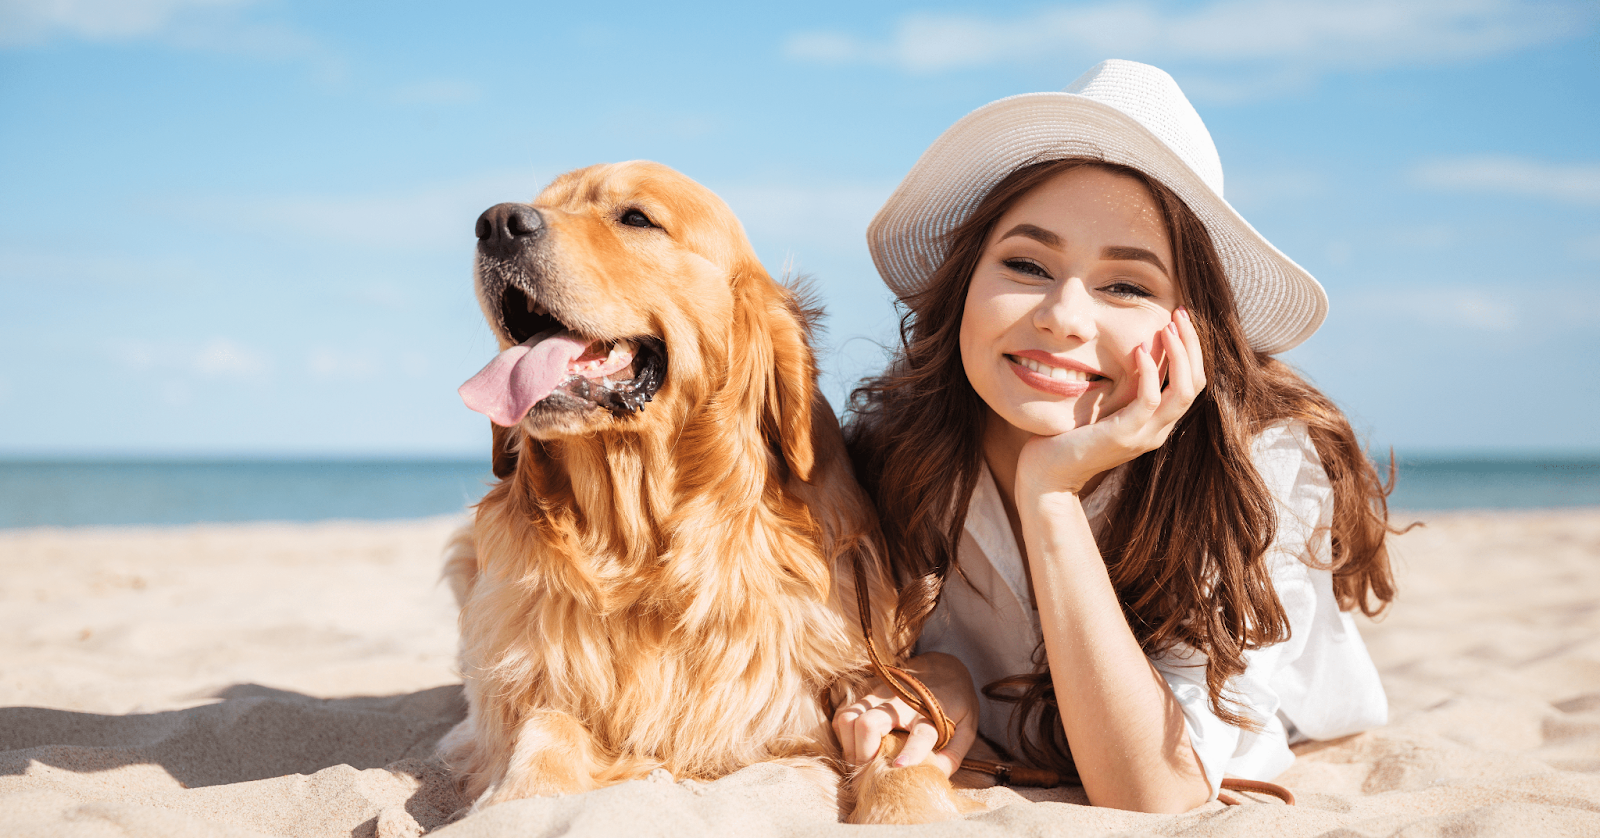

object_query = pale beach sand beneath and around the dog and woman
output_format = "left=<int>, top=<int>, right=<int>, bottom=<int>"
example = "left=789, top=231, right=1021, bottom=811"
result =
left=0, top=510, right=1600, bottom=838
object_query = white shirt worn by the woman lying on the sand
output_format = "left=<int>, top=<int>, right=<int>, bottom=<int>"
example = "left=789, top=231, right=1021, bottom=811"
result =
left=917, top=422, right=1389, bottom=798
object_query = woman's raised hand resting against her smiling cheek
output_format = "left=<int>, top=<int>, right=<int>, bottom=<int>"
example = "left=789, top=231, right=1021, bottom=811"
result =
left=1016, top=309, right=1205, bottom=497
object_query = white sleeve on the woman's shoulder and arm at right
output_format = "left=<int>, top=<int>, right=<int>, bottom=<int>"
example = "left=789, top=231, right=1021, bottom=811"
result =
left=1152, top=422, right=1389, bottom=798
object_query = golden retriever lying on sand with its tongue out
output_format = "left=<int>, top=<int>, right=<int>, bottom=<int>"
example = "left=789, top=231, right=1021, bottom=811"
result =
left=440, top=162, right=981, bottom=822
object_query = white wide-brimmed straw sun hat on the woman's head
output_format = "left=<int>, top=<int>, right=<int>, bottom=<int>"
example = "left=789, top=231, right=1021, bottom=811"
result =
left=867, top=59, right=1328, bottom=353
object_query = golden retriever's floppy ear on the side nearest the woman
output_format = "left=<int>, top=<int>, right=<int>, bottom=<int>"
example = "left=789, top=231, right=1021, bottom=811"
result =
left=762, top=291, right=816, bottom=481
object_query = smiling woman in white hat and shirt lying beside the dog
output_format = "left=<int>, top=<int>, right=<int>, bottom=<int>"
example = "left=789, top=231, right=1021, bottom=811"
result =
left=835, top=61, right=1394, bottom=811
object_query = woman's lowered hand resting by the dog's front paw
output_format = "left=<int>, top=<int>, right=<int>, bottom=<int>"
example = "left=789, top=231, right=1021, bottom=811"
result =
left=834, top=652, right=978, bottom=777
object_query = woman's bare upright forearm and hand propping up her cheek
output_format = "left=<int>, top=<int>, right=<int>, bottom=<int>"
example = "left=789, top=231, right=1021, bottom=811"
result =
left=1011, top=309, right=1211, bottom=812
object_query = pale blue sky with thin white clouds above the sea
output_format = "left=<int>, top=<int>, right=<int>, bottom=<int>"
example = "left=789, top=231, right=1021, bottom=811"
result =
left=0, top=0, right=1600, bottom=456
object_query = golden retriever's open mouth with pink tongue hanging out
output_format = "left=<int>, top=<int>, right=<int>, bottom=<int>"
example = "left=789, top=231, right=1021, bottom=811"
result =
left=461, top=286, right=666, bottom=427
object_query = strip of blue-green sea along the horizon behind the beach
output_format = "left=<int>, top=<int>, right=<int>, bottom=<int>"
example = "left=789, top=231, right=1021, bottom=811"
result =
left=0, top=457, right=1600, bottom=528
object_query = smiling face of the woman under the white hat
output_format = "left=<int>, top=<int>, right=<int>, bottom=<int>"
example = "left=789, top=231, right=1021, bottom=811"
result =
left=962, top=166, right=1179, bottom=435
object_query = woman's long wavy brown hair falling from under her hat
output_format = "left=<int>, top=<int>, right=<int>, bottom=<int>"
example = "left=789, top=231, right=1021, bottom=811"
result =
left=846, top=158, right=1394, bottom=774
